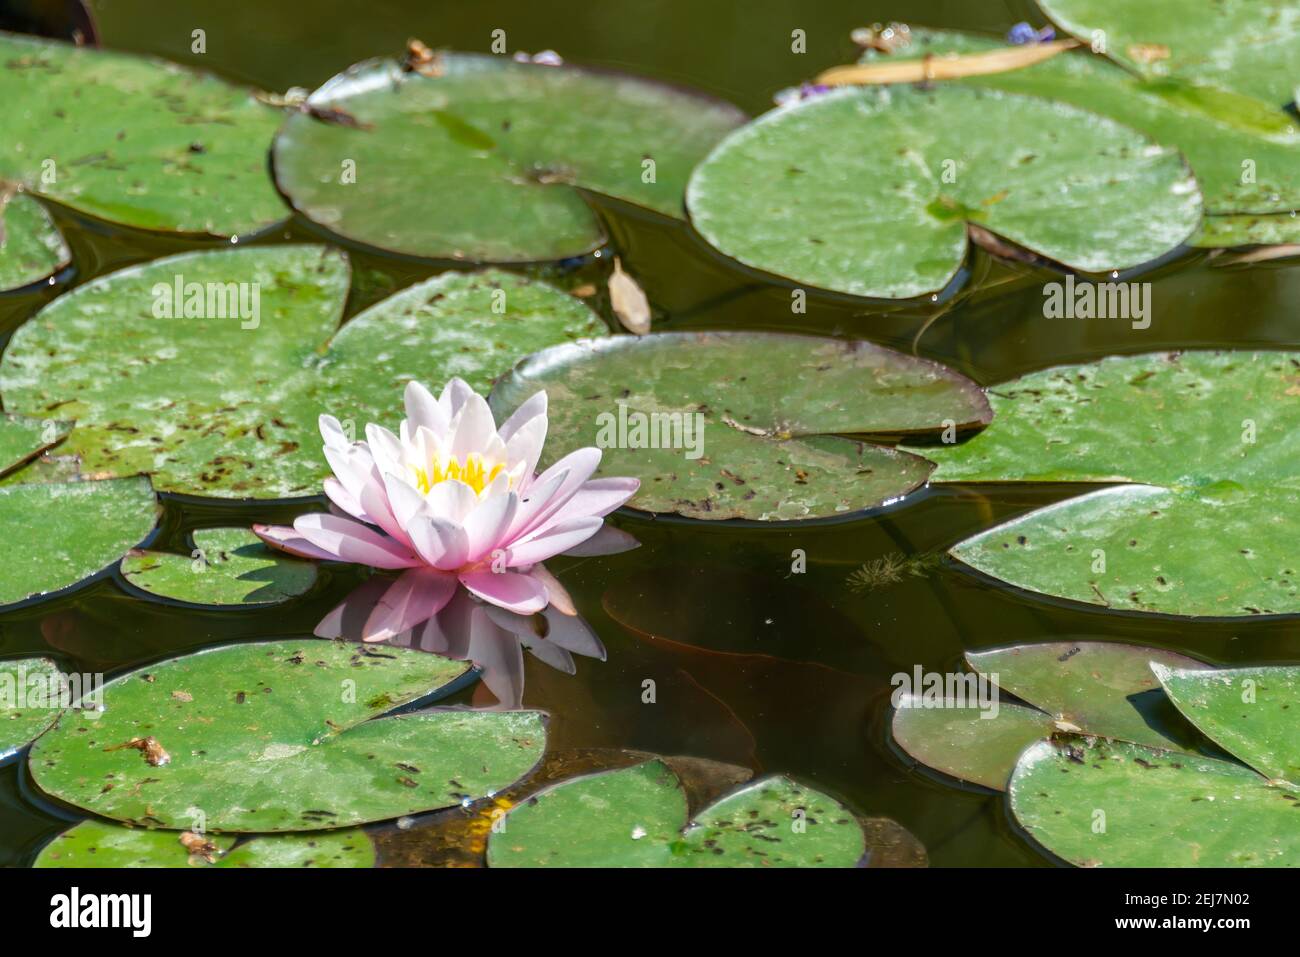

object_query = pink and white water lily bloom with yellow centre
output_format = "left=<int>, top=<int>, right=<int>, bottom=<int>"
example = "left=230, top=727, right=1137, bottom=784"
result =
left=254, top=378, right=640, bottom=641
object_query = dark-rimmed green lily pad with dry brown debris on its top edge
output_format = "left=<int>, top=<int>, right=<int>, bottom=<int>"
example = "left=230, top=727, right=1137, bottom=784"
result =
left=274, top=52, right=745, bottom=263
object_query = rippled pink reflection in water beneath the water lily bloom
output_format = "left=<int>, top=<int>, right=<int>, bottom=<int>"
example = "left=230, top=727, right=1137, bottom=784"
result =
left=316, top=577, right=605, bottom=709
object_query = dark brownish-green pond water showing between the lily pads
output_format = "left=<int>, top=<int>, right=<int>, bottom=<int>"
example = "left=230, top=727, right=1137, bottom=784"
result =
left=0, top=0, right=1300, bottom=866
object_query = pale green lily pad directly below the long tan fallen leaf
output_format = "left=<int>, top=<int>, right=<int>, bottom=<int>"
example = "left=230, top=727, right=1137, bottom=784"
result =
left=686, top=85, right=1201, bottom=299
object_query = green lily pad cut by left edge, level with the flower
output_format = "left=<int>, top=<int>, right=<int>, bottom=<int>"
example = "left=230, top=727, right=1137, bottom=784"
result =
left=0, top=477, right=159, bottom=607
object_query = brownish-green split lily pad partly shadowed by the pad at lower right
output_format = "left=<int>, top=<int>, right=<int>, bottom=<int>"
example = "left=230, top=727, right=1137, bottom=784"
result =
left=892, top=641, right=1208, bottom=791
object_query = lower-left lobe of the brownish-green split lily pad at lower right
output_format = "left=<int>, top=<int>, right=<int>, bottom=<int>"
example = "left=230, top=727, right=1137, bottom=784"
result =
left=891, top=698, right=1056, bottom=791
